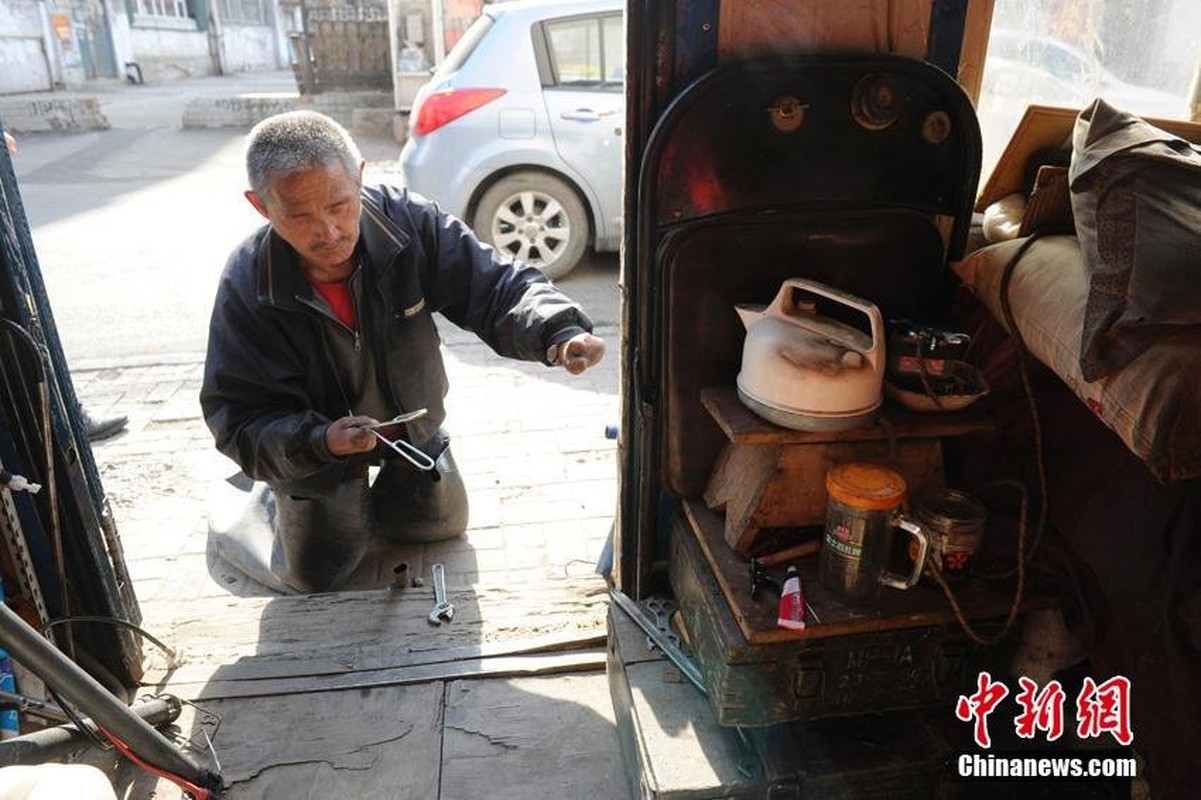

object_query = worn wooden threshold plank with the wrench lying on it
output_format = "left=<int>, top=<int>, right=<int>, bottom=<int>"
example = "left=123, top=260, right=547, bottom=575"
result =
left=143, top=574, right=609, bottom=688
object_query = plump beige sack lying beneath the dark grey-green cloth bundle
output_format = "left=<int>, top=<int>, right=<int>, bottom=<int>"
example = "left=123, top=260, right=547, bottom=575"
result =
left=955, top=230, right=1201, bottom=483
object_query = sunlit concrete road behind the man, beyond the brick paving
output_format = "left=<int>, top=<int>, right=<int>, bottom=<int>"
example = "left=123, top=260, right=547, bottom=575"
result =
left=13, top=73, right=620, bottom=369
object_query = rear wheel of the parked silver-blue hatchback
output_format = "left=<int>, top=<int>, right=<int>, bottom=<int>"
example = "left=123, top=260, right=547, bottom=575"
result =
left=472, top=172, right=591, bottom=280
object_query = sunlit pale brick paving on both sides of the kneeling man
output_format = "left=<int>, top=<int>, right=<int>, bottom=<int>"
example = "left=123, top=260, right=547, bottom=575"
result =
left=72, top=317, right=619, bottom=605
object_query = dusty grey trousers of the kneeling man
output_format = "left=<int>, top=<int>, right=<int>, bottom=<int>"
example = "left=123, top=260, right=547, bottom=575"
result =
left=210, top=432, right=467, bottom=593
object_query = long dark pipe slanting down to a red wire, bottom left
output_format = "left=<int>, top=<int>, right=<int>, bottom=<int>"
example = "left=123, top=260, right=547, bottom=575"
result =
left=0, top=604, right=222, bottom=789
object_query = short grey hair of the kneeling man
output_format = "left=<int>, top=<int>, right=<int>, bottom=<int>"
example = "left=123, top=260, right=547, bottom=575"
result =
left=246, top=111, right=363, bottom=201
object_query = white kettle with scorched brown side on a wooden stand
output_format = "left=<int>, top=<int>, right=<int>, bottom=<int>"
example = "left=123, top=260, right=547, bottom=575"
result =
left=735, top=277, right=886, bottom=431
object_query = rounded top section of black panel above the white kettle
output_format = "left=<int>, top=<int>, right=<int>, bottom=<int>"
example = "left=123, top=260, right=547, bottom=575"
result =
left=640, top=56, right=980, bottom=236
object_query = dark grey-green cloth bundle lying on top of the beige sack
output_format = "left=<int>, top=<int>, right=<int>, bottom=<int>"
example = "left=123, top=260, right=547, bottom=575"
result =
left=1069, top=100, right=1201, bottom=381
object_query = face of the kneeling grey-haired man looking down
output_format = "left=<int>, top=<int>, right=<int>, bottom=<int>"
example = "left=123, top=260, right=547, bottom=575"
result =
left=246, top=159, right=363, bottom=281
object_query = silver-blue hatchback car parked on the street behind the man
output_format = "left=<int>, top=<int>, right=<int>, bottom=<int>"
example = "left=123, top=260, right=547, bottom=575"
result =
left=400, top=0, right=626, bottom=277
